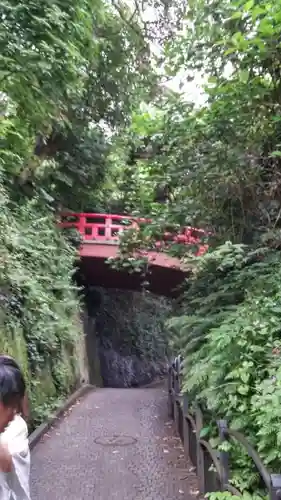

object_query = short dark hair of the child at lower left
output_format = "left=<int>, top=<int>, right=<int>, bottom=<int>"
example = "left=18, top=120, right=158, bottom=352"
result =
left=0, top=355, right=26, bottom=409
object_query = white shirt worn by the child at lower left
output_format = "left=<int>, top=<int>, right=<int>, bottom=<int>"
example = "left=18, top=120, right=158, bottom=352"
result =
left=0, top=415, right=30, bottom=500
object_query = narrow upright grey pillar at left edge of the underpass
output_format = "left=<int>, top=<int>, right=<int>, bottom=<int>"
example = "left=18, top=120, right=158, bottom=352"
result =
left=83, top=311, right=103, bottom=387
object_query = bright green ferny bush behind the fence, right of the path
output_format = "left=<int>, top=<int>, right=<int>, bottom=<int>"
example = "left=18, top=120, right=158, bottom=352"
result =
left=169, top=243, right=281, bottom=491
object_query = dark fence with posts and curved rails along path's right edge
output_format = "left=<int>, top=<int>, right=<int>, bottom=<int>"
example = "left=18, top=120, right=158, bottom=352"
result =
left=168, top=356, right=281, bottom=500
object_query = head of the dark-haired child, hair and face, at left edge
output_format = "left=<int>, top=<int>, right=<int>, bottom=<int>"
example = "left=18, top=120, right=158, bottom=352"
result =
left=0, top=355, right=25, bottom=432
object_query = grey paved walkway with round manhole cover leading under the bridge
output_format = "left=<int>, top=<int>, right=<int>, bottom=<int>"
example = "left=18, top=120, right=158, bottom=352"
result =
left=31, top=386, right=197, bottom=500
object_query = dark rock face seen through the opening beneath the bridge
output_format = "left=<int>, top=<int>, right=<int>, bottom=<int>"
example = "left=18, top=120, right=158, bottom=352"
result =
left=83, top=289, right=170, bottom=387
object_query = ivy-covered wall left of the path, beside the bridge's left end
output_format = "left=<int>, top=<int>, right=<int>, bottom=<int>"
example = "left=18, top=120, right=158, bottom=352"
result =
left=0, top=189, right=81, bottom=425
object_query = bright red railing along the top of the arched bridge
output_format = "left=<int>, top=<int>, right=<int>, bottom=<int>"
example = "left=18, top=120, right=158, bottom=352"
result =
left=59, top=212, right=208, bottom=255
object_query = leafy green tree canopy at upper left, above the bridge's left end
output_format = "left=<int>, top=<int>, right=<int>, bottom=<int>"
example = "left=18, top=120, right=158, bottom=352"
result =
left=0, top=0, right=160, bottom=211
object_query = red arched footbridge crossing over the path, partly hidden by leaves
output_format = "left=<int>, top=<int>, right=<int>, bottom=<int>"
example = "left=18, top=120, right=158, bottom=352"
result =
left=60, top=213, right=208, bottom=297
